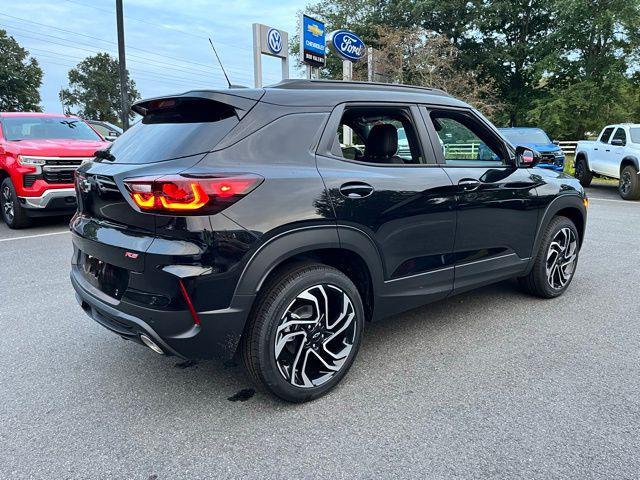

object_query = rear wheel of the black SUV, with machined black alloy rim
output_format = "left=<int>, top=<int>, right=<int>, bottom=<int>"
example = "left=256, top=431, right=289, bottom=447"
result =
left=242, top=263, right=364, bottom=403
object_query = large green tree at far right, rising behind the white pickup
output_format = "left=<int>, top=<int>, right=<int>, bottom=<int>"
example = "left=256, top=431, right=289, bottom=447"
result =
left=528, top=0, right=640, bottom=140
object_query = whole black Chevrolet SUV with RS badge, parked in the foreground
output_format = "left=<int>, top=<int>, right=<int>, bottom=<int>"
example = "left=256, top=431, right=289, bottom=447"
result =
left=71, top=80, right=587, bottom=402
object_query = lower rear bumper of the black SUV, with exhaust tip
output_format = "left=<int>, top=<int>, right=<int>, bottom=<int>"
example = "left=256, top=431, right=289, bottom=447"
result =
left=71, top=265, right=255, bottom=360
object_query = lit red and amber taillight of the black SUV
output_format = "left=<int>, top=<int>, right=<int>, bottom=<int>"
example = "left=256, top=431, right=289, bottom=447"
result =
left=124, top=174, right=263, bottom=214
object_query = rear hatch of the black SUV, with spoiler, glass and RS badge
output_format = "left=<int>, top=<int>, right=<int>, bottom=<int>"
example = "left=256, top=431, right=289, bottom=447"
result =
left=71, top=90, right=263, bottom=312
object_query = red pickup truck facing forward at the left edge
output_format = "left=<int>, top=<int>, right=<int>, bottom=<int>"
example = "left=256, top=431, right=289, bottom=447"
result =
left=0, top=112, right=109, bottom=228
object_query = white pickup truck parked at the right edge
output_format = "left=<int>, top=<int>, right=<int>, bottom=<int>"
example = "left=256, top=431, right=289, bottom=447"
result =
left=575, top=123, right=640, bottom=200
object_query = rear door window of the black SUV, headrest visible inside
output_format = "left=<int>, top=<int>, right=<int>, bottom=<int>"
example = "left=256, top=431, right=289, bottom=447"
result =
left=332, top=107, right=425, bottom=165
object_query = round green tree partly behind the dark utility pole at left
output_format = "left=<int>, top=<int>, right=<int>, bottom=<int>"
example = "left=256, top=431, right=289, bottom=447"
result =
left=60, top=53, right=140, bottom=124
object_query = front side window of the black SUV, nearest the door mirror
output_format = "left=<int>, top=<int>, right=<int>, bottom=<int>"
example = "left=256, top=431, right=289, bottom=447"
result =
left=429, top=110, right=509, bottom=166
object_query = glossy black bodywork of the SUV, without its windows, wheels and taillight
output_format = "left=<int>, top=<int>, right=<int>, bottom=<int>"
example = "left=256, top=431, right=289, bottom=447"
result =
left=71, top=81, right=586, bottom=359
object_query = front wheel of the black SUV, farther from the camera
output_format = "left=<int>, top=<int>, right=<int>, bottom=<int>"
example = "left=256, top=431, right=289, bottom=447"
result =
left=518, top=216, right=580, bottom=298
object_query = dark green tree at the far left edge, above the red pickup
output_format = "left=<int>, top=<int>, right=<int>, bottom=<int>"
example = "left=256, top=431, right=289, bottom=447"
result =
left=0, top=30, right=42, bottom=111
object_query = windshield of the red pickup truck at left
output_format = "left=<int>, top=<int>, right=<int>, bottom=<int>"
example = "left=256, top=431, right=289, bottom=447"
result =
left=2, top=117, right=102, bottom=141
